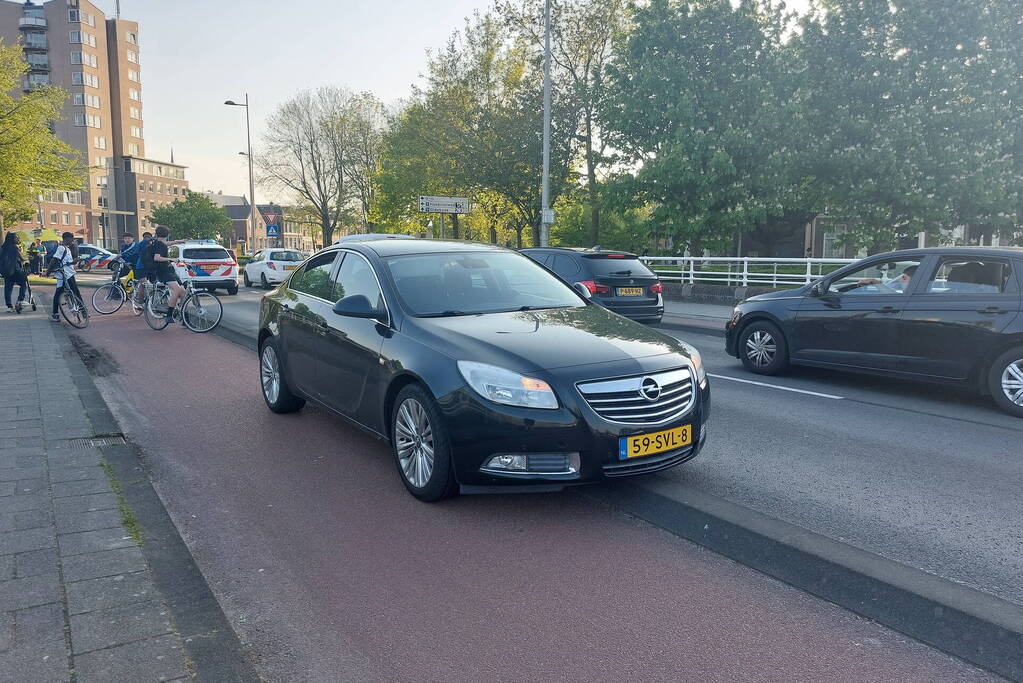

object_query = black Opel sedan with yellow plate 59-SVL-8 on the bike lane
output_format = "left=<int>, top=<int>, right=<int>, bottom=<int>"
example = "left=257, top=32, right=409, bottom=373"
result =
left=259, top=240, right=710, bottom=501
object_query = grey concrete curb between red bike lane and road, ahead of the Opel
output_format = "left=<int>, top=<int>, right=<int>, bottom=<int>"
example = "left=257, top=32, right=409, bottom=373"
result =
left=581, top=477, right=1023, bottom=681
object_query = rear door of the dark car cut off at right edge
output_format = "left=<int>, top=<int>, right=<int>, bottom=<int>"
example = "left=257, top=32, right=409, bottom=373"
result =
left=899, top=254, right=1020, bottom=379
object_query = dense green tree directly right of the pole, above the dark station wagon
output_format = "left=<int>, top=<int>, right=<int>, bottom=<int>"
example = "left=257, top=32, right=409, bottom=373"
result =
left=601, top=0, right=800, bottom=254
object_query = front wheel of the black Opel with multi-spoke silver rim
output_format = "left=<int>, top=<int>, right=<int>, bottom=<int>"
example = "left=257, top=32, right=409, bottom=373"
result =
left=391, top=384, right=458, bottom=503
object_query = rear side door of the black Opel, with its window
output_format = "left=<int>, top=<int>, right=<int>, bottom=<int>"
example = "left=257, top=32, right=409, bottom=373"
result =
left=279, top=252, right=338, bottom=398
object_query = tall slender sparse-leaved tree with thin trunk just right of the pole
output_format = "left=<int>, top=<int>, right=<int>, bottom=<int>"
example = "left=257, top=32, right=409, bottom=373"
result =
left=500, top=0, right=628, bottom=244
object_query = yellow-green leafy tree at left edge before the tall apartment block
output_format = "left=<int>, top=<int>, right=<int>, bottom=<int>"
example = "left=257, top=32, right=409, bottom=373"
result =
left=0, top=41, right=86, bottom=225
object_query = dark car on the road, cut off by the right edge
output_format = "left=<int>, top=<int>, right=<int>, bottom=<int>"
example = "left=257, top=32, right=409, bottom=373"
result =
left=725, top=247, right=1023, bottom=417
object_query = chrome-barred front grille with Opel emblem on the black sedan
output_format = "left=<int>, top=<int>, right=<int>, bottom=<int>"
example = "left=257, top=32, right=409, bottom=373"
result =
left=578, top=368, right=696, bottom=424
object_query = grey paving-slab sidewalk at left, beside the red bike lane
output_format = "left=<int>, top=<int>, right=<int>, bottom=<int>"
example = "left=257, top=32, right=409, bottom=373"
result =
left=0, top=307, right=189, bottom=683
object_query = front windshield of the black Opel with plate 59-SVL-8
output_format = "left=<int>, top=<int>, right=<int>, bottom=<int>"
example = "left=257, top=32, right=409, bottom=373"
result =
left=384, top=252, right=583, bottom=316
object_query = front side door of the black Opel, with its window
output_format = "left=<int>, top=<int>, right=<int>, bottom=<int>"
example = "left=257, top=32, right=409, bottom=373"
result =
left=316, top=252, right=390, bottom=429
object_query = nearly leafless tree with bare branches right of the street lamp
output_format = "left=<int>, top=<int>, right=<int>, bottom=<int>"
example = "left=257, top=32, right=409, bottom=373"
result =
left=257, top=86, right=352, bottom=244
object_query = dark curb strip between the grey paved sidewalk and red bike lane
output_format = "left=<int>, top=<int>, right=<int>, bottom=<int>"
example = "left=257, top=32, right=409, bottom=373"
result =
left=56, top=300, right=260, bottom=683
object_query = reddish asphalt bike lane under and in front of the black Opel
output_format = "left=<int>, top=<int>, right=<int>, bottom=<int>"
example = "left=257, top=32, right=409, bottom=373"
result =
left=72, top=312, right=993, bottom=681
